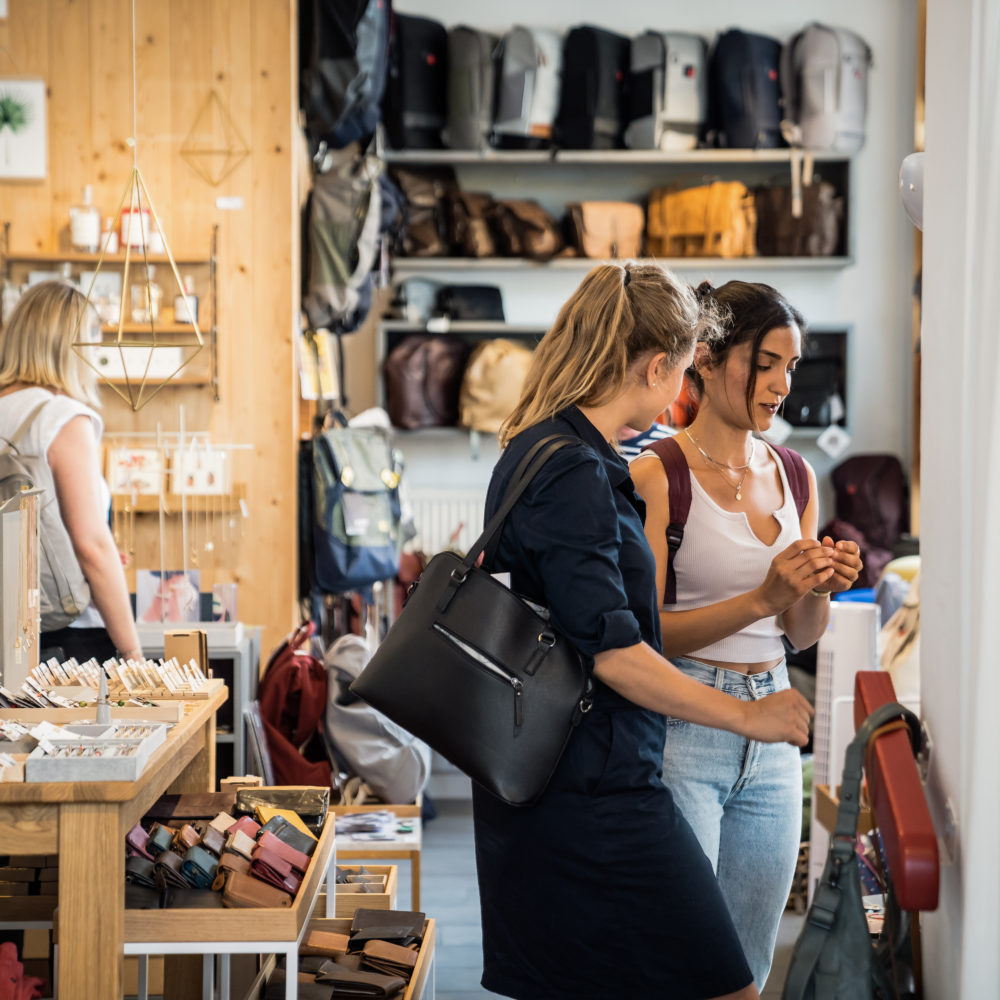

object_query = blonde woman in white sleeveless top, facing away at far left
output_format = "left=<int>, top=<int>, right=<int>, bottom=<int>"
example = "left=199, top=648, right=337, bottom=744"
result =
left=0, top=281, right=142, bottom=662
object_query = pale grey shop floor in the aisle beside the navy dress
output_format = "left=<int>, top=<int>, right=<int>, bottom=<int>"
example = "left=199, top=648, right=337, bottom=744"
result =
left=397, top=799, right=802, bottom=1000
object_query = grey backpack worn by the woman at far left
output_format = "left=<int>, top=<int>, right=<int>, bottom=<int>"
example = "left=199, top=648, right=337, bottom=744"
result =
left=0, top=397, right=90, bottom=632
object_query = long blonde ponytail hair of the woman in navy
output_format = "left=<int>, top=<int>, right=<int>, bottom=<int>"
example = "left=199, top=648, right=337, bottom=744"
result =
left=500, top=261, right=718, bottom=446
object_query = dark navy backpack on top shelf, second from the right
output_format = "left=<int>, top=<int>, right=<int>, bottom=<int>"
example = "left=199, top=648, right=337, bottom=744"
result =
left=708, top=29, right=785, bottom=149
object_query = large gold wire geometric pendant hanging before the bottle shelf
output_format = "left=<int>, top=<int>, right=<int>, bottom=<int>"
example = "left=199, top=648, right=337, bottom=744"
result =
left=72, top=0, right=205, bottom=410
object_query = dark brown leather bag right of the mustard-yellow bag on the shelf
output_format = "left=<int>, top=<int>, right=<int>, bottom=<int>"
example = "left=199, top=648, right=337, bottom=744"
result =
left=754, top=181, right=844, bottom=257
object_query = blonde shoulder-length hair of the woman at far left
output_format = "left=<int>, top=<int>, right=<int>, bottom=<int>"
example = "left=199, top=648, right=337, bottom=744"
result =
left=0, top=281, right=100, bottom=408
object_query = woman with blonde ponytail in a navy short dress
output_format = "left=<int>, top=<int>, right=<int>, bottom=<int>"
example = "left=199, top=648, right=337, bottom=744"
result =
left=473, top=263, right=816, bottom=1000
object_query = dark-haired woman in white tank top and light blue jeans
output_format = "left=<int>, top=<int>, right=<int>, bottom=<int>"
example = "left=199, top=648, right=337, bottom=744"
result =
left=631, top=281, right=861, bottom=989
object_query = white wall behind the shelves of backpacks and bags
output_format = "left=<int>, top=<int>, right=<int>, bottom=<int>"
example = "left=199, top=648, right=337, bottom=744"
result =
left=386, top=0, right=916, bottom=516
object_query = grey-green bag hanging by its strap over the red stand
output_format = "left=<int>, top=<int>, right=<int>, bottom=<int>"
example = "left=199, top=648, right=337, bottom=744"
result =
left=782, top=702, right=920, bottom=1000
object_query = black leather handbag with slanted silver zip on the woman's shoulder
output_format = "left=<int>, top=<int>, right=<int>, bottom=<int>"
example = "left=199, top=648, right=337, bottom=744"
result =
left=350, top=435, right=591, bottom=805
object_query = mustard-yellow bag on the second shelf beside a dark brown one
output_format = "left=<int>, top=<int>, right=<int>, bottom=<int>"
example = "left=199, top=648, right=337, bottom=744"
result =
left=646, top=181, right=757, bottom=257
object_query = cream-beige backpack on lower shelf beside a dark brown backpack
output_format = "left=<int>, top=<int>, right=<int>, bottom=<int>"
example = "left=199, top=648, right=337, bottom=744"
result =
left=458, top=337, right=531, bottom=434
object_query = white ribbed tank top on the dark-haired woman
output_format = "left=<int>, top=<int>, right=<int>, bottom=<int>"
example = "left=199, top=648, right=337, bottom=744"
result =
left=667, top=442, right=802, bottom=663
